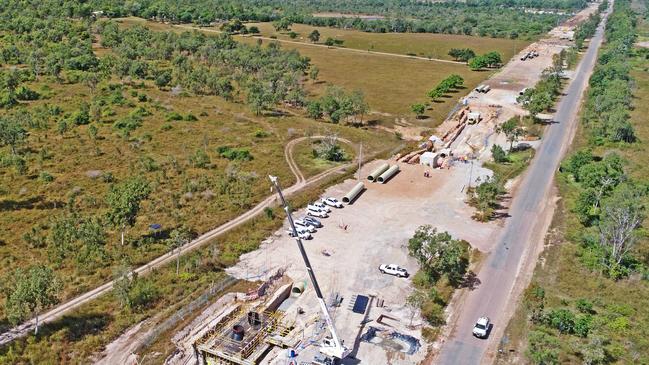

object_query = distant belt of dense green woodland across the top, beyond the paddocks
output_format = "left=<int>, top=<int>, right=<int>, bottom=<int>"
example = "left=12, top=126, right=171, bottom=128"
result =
left=91, top=0, right=586, bottom=39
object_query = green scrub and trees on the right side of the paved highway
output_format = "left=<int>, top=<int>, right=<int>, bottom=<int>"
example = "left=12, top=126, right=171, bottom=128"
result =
left=501, top=0, right=649, bottom=364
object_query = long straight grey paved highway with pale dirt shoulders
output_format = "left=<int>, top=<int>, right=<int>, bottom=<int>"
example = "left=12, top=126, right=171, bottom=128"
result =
left=435, top=5, right=606, bottom=365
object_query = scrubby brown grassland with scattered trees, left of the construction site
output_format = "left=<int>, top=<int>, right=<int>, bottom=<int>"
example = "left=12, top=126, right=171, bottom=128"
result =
left=0, top=1, right=399, bottom=363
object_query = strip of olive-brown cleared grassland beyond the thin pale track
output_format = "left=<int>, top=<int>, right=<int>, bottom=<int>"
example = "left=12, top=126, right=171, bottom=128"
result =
left=246, top=23, right=531, bottom=60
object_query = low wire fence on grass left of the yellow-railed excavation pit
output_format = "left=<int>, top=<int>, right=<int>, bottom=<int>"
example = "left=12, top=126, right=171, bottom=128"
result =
left=136, top=276, right=239, bottom=352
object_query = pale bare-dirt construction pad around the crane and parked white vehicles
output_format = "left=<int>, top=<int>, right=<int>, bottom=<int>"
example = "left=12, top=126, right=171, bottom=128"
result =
left=228, top=161, right=500, bottom=364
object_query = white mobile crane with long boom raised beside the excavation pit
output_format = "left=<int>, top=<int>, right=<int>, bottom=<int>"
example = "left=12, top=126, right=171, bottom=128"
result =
left=268, top=175, right=349, bottom=360
